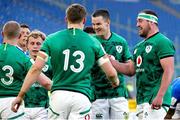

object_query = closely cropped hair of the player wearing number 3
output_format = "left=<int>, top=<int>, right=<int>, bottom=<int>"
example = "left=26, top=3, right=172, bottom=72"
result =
left=3, top=21, right=20, bottom=39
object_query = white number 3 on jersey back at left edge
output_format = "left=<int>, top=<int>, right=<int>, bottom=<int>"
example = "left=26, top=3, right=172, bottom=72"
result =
left=1, top=65, right=14, bottom=85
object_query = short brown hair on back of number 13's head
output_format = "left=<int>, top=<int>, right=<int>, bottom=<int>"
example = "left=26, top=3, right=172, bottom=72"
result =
left=66, top=4, right=86, bottom=23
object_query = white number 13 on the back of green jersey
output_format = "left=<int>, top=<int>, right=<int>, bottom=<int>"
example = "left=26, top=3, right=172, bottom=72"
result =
left=63, top=49, right=85, bottom=73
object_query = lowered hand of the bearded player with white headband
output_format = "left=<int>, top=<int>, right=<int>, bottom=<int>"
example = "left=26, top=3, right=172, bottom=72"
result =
left=151, top=95, right=163, bottom=110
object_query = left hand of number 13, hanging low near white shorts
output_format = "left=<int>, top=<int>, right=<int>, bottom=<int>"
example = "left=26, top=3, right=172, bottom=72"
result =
left=11, top=97, right=23, bottom=112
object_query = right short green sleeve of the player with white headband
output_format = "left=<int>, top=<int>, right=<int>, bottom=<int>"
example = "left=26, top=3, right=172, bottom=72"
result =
left=157, top=38, right=175, bottom=59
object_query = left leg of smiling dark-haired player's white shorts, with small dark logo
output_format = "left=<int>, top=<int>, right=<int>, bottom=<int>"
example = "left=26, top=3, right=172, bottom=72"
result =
left=91, top=99, right=110, bottom=119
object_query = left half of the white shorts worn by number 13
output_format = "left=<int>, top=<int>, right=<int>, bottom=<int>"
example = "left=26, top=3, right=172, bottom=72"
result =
left=48, top=90, right=73, bottom=119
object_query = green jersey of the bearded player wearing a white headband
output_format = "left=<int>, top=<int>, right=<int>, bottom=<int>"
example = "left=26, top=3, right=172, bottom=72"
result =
left=133, top=33, right=175, bottom=105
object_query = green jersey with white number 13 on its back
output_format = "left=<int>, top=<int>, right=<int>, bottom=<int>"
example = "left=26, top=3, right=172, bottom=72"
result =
left=41, top=29, right=105, bottom=100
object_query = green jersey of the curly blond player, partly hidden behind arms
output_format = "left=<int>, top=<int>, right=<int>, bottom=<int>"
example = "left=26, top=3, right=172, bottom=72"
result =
left=24, top=58, right=52, bottom=108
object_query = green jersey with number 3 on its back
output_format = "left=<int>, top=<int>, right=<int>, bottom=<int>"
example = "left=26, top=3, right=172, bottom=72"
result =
left=0, top=44, right=31, bottom=98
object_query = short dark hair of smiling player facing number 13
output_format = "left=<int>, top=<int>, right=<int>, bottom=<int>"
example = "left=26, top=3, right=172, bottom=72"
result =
left=92, top=9, right=110, bottom=19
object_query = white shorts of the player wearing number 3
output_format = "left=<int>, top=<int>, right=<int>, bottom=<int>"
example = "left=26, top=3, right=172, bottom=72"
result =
left=0, top=97, right=24, bottom=120
